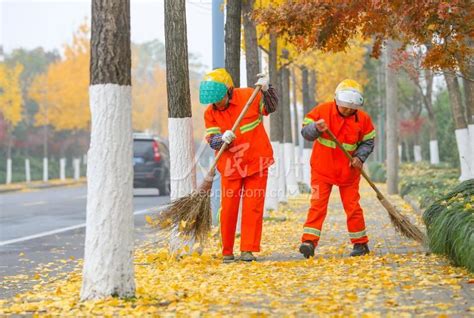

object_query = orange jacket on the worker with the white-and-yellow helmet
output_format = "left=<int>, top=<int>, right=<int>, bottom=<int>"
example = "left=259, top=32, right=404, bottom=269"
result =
left=303, top=101, right=375, bottom=185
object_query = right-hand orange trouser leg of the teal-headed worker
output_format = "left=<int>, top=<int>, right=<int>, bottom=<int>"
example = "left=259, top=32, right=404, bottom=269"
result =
left=240, top=169, right=268, bottom=252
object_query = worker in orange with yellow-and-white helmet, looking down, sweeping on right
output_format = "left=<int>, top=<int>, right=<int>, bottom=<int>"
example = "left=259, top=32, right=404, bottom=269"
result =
left=299, top=79, right=375, bottom=258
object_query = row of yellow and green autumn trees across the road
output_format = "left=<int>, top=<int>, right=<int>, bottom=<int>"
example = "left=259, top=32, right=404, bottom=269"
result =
left=0, top=22, right=204, bottom=183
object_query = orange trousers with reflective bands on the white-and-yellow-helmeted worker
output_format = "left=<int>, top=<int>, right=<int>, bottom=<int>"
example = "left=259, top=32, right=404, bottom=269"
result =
left=301, top=178, right=369, bottom=246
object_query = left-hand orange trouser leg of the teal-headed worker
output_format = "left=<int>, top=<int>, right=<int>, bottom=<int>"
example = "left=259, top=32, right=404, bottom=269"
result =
left=220, top=177, right=242, bottom=255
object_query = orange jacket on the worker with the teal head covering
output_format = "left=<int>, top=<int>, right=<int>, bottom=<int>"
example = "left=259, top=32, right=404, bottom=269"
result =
left=204, top=88, right=274, bottom=179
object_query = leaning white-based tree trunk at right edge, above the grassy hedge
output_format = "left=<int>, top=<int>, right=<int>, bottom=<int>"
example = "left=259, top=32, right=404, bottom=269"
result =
left=444, top=72, right=473, bottom=181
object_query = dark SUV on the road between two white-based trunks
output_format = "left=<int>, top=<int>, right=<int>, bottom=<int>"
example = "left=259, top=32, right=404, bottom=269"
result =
left=133, top=133, right=170, bottom=195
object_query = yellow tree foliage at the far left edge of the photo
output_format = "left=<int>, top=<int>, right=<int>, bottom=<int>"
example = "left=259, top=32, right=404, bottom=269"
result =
left=0, top=63, right=23, bottom=129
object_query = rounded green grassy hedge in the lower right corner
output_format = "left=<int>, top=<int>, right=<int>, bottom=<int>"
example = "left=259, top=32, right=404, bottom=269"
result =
left=423, top=179, right=474, bottom=272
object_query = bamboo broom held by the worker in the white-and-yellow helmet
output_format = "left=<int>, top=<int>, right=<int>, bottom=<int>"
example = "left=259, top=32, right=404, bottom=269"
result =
left=326, top=129, right=426, bottom=244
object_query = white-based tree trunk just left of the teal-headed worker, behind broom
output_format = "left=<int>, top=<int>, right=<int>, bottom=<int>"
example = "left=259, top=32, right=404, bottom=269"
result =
left=165, top=0, right=196, bottom=253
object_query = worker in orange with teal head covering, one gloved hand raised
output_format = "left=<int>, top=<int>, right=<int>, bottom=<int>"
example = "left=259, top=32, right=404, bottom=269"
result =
left=199, top=69, right=278, bottom=263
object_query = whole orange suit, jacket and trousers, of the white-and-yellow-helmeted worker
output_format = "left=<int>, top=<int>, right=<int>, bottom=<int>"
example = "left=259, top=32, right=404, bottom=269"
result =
left=302, top=101, right=375, bottom=246
